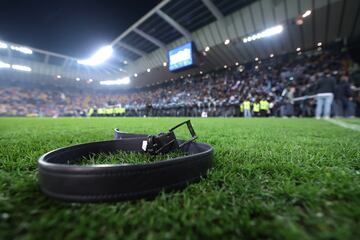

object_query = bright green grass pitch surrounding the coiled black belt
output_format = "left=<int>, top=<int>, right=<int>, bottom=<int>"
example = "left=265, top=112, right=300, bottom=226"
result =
left=0, top=118, right=360, bottom=240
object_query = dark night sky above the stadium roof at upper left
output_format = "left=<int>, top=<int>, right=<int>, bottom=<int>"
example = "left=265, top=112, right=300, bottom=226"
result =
left=0, top=0, right=160, bottom=58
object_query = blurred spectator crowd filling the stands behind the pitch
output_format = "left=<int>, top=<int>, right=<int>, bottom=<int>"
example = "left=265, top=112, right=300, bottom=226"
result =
left=0, top=46, right=360, bottom=117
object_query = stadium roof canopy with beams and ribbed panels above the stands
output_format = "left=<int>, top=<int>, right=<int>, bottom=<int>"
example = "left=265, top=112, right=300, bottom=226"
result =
left=0, top=0, right=360, bottom=87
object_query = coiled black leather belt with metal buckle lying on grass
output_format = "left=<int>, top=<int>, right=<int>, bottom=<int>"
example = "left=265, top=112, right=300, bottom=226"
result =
left=39, top=121, right=213, bottom=202
